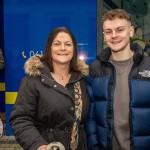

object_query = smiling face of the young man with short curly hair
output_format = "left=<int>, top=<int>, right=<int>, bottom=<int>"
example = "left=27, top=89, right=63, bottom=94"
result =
left=103, top=18, right=134, bottom=52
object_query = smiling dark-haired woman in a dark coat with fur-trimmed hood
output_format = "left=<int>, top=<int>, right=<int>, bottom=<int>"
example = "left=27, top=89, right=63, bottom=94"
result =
left=10, top=27, right=89, bottom=150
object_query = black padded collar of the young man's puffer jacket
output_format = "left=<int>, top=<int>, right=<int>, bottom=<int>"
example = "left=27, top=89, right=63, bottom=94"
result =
left=96, top=43, right=144, bottom=66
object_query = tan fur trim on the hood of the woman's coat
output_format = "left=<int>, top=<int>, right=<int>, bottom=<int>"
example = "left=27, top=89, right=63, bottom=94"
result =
left=24, top=55, right=89, bottom=76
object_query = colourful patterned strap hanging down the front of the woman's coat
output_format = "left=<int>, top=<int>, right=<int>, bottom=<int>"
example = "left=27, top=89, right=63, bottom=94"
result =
left=70, top=82, right=82, bottom=150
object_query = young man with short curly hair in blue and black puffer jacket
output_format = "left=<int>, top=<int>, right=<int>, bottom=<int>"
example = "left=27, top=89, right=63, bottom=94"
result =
left=86, top=9, right=150, bottom=150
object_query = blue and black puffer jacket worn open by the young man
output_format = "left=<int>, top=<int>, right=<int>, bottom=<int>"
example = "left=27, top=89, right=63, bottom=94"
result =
left=86, top=44, right=150, bottom=150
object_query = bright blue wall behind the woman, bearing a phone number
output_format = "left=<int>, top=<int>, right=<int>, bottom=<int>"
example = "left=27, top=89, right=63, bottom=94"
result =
left=4, top=0, right=96, bottom=135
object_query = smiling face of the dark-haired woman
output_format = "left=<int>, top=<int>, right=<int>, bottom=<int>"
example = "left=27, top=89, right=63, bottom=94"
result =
left=51, top=32, right=74, bottom=64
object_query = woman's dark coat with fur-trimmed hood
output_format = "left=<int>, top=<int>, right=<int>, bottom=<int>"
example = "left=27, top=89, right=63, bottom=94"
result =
left=10, top=55, right=89, bottom=150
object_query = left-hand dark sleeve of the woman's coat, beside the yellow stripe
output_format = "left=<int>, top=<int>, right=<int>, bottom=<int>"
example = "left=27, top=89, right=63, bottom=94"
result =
left=9, top=77, right=47, bottom=150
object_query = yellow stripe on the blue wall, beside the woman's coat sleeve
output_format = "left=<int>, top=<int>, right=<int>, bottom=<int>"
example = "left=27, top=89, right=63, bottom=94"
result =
left=5, top=92, right=18, bottom=104
